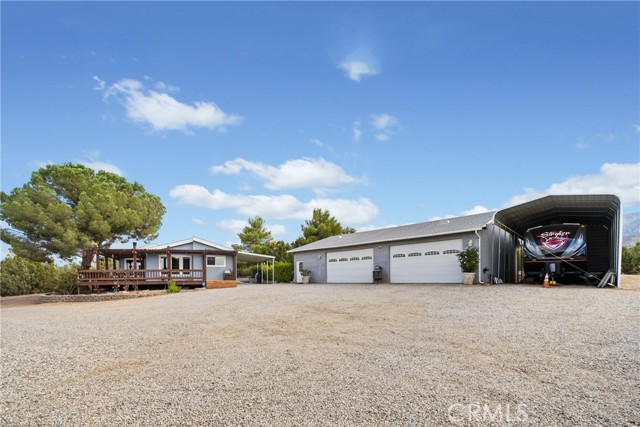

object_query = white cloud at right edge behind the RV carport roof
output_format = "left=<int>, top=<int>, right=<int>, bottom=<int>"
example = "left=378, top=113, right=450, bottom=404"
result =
left=505, top=163, right=640, bottom=206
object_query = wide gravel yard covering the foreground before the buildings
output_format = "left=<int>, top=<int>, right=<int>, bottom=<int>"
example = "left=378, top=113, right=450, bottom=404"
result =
left=1, top=285, right=640, bottom=426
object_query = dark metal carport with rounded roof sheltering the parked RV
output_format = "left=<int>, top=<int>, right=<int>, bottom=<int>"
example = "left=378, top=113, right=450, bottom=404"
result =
left=494, top=194, right=622, bottom=286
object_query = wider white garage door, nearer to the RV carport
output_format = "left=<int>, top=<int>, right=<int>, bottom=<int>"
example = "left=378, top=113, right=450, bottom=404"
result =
left=390, top=239, right=462, bottom=283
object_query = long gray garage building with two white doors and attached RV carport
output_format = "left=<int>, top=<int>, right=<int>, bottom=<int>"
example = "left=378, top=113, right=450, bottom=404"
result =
left=290, top=195, right=622, bottom=283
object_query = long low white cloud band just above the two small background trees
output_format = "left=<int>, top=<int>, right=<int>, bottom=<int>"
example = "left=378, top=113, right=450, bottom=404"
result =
left=169, top=184, right=378, bottom=226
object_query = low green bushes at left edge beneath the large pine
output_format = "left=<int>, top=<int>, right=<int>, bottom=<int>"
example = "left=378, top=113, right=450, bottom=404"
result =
left=0, top=255, right=78, bottom=296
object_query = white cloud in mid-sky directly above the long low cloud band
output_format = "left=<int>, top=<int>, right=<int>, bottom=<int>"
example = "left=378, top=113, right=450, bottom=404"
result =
left=210, top=158, right=365, bottom=191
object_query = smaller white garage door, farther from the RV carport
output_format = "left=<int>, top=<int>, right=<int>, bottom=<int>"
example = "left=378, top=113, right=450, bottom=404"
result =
left=327, top=249, right=373, bottom=283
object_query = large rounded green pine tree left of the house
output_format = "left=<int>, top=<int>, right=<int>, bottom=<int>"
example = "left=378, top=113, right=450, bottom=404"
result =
left=0, top=163, right=165, bottom=269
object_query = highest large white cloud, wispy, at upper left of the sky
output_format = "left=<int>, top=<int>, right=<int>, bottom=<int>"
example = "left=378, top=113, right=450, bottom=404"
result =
left=105, top=79, right=243, bottom=131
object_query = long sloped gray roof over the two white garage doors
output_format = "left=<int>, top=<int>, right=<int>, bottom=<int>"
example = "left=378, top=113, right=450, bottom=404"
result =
left=289, top=212, right=495, bottom=253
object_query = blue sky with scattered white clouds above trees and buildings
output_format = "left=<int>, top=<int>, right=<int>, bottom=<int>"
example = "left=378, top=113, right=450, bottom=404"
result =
left=1, top=2, right=640, bottom=244
